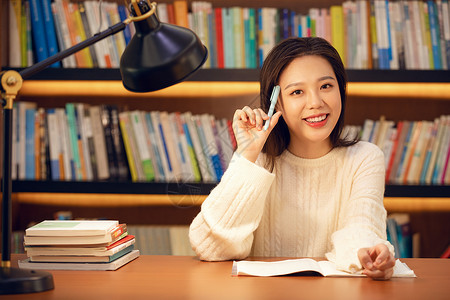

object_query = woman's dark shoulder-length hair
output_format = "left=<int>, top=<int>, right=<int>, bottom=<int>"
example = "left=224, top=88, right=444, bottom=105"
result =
left=260, top=37, right=357, bottom=170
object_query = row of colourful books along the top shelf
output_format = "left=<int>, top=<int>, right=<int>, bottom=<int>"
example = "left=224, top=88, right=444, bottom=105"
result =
left=8, top=0, right=450, bottom=70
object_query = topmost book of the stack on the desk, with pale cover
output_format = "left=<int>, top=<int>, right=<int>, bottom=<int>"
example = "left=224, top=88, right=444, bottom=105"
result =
left=25, top=220, right=119, bottom=237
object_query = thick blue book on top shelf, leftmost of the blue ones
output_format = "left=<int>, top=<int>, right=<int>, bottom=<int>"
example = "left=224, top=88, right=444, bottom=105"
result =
left=30, top=0, right=48, bottom=62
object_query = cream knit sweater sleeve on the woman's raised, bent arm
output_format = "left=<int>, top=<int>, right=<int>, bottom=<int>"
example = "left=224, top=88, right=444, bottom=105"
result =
left=189, top=154, right=275, bottom=261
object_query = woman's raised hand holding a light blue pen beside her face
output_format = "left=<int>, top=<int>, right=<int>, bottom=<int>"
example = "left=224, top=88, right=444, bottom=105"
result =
left=233, top=106, right=281, bottom=162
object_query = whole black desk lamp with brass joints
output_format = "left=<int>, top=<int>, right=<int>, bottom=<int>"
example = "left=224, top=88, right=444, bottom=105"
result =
left=0, top=0, right=208, bottom=294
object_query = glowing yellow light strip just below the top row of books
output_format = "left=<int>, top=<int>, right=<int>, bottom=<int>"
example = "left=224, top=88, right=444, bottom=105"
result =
left=20, top=80, right=450, bottom=100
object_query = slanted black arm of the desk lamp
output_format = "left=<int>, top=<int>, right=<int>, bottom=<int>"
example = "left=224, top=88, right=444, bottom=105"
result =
left=19, top=19, right=131, bottom=79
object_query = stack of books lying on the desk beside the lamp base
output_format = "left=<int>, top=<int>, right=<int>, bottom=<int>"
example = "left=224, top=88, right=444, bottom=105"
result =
left=19, top=220, right=139, bottom=270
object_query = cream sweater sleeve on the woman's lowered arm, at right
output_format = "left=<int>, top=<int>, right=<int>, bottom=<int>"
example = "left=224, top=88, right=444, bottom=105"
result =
left=326, top=145, right=394, bottom=272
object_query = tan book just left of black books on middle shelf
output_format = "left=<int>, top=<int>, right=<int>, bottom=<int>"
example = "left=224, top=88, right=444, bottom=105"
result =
left=89, top=105, right=110, bottom=180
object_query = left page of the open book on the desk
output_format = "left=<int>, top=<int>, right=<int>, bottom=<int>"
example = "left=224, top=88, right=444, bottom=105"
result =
left=231, top=258, right=323, bottom=276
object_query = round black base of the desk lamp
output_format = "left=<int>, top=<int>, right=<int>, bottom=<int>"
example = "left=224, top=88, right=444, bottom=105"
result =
left=0, top=267, right=54, bottom=295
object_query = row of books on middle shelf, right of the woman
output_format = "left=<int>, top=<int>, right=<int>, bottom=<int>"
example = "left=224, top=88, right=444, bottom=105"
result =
left=343, top=115, right=450, bottom=185
